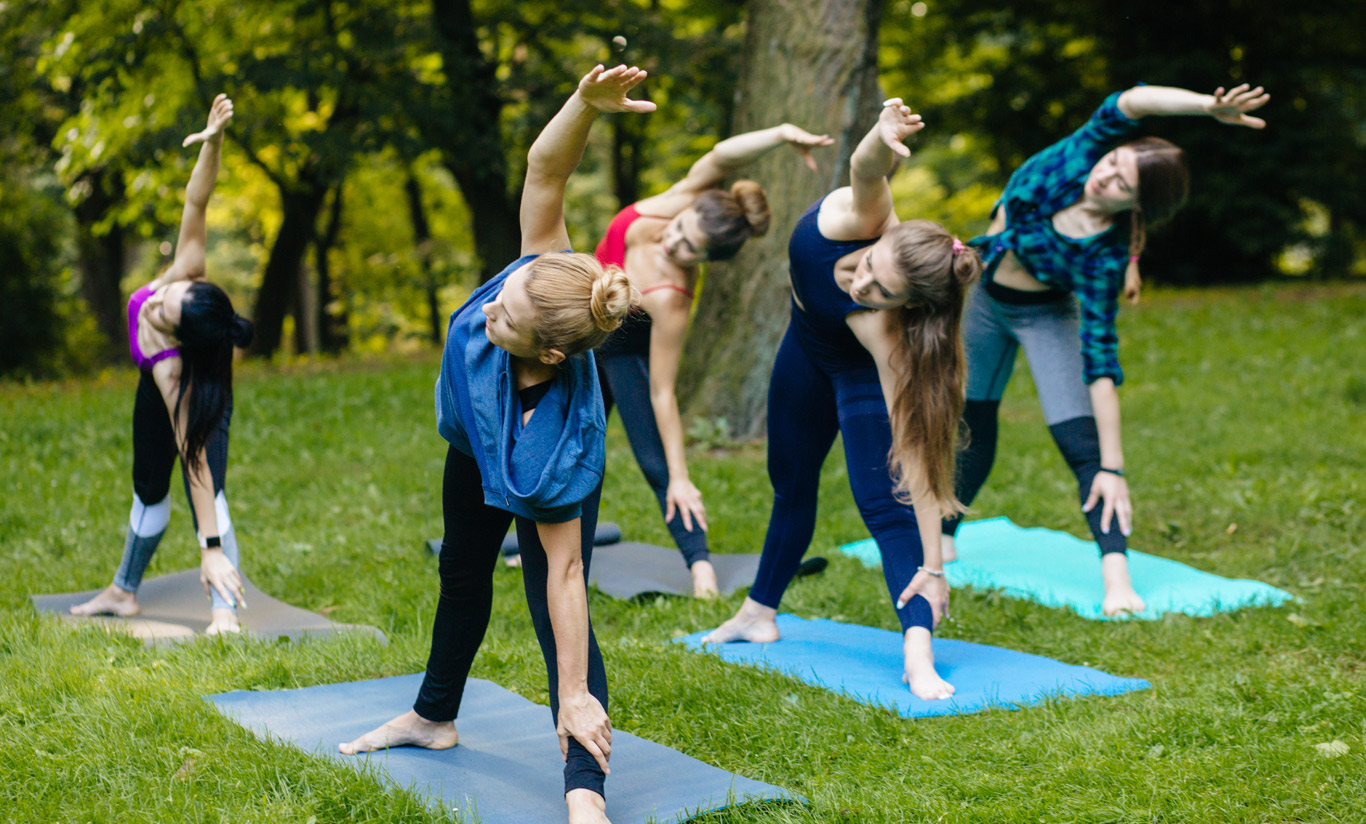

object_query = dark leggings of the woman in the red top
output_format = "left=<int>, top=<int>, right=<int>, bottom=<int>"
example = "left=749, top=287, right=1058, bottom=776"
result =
left=597, top=353, right=710, bottom=568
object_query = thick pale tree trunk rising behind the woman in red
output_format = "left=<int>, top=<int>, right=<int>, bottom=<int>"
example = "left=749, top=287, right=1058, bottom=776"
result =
left=679, top=0, right=884, bottom=437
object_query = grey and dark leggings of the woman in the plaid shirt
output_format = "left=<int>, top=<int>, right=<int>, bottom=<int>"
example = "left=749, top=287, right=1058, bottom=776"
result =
left=944, top=281, right=1126, bottom=555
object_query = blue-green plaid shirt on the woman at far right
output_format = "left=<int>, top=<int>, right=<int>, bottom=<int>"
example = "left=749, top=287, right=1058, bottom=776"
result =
left=971, top=92, right=1139, bottom=385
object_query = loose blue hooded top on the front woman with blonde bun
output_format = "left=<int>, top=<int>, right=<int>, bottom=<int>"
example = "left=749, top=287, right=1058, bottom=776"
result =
left=436, top=254, right=607, bottom=523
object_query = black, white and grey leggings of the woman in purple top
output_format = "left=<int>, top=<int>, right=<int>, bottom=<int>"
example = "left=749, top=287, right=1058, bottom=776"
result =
left=113, top=372, right=240, bottom=609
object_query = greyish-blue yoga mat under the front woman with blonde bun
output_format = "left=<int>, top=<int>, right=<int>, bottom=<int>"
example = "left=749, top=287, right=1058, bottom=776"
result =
left=209, top=674, right=800, bottom=824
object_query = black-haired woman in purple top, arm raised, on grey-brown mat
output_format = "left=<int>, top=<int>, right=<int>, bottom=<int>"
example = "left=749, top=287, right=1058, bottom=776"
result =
left=71, top=94, right=251, bottom=634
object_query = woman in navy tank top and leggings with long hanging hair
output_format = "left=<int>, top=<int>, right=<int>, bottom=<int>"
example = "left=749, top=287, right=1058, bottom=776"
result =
left=703, top=98, right=981, bottom=700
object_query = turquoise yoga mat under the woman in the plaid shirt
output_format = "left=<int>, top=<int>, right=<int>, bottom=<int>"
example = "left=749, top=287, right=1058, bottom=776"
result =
left=840, top=518, right=1295, bottom=620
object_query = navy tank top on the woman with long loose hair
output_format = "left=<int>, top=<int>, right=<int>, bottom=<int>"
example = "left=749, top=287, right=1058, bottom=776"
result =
left=787, top=195, right=877, bottom=366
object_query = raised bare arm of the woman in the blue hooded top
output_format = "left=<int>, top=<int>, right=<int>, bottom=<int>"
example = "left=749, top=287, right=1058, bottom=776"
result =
left=520, top=66, right=654, bottom=254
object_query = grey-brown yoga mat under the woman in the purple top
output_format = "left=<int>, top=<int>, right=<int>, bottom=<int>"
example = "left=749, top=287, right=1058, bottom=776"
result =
left=30, top=570, right=385, bottom=644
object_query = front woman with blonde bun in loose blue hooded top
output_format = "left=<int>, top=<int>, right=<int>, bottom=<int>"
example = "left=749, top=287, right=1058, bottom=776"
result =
left=340, top=66, right=654, bottom=824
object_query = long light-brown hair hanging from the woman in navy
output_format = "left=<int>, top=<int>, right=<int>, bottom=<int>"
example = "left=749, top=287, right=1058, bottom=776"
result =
left=888, top=220, right=982, bottom=517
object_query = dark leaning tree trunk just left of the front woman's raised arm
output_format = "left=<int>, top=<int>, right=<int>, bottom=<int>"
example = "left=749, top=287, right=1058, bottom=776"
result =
left=432, top=0, right=522, bottom=283
